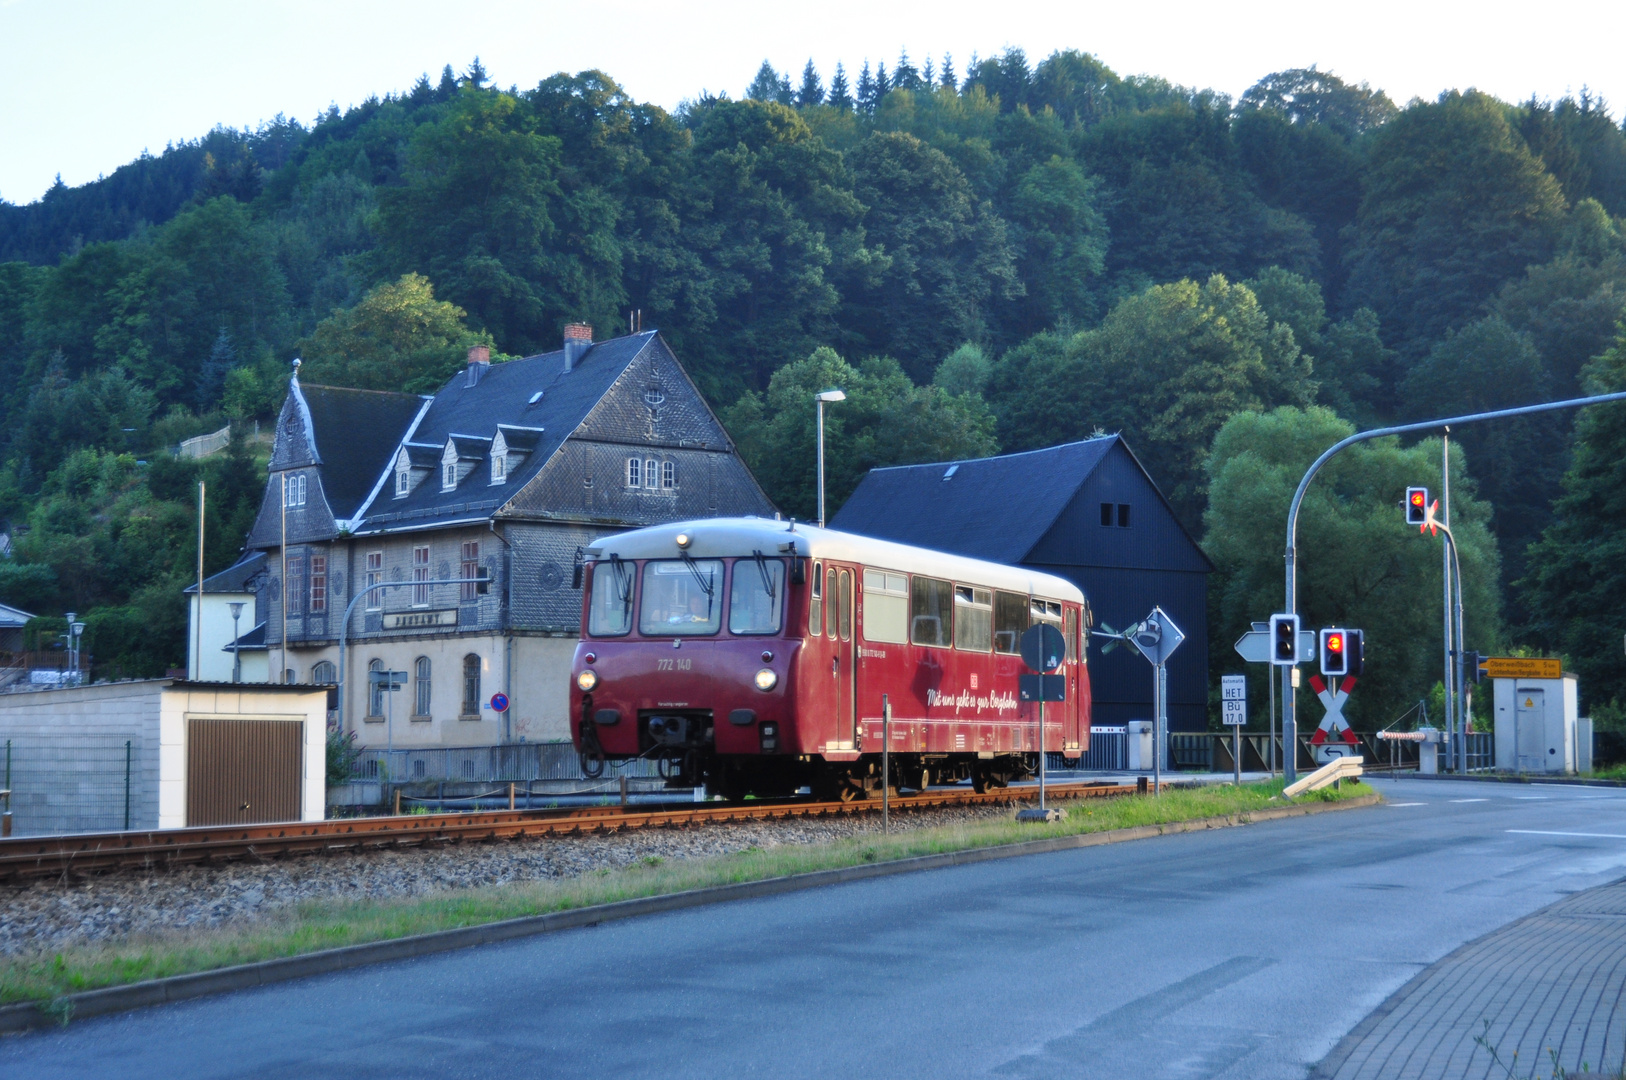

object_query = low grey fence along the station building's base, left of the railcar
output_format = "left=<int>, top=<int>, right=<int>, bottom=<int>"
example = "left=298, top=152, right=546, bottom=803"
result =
left=350, top=743, right=660, bottom=784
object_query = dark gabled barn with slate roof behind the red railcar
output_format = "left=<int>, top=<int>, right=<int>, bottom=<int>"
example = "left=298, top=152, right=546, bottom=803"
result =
left=831, top=436, right=1213, bottom=732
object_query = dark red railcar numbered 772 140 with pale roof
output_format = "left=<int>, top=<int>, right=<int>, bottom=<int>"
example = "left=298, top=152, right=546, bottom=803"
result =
left=571, top=517, right=1089, bottom=799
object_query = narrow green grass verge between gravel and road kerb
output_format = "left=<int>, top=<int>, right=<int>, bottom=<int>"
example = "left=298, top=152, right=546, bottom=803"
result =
left=0, top=782, right=1372, bottom=1004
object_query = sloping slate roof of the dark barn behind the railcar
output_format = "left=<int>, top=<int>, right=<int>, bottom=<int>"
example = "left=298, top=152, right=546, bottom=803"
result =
left=829, top=436, right=1119, bottom=563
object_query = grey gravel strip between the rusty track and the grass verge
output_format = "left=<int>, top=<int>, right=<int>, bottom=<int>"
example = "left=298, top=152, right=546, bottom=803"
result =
left=0, top=793, right=1013, bottom=955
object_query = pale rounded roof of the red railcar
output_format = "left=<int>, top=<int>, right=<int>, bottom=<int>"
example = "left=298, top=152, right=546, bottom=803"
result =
left=587, top=517, right=1085, bottom=603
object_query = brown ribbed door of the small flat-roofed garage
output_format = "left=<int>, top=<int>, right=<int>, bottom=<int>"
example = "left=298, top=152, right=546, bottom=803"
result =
left=187, top=719, right=304, bottom=825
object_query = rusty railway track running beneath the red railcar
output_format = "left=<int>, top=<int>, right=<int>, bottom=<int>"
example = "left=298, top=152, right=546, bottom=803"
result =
left=0, top=782, right=1137, bottom=882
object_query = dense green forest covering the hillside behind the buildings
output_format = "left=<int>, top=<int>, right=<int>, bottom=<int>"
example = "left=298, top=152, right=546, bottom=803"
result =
left=0, top=50, right=1626, bottom=727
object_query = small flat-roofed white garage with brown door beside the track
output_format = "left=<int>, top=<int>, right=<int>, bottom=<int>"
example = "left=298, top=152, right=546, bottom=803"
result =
left=0, top=678, right=327, bottom=836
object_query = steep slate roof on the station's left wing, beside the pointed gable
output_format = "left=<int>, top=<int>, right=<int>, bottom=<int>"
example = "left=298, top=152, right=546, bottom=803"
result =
left=299, top=383, right=426, bottom=519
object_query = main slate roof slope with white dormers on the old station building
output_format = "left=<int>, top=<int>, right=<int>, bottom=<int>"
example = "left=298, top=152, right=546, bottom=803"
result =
left=357, top=330, right=655, bottom=532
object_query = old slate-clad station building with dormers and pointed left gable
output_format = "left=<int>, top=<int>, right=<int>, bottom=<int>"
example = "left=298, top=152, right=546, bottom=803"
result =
left=190, top=325, right=774, bottom=748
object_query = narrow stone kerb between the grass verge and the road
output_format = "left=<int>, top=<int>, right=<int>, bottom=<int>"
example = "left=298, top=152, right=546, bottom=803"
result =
left=0, top=794, right=1378, bottom=1034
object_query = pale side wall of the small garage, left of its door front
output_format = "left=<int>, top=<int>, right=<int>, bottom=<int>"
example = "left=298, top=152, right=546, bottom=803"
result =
left=0, top=735, right=143, bottom=836
